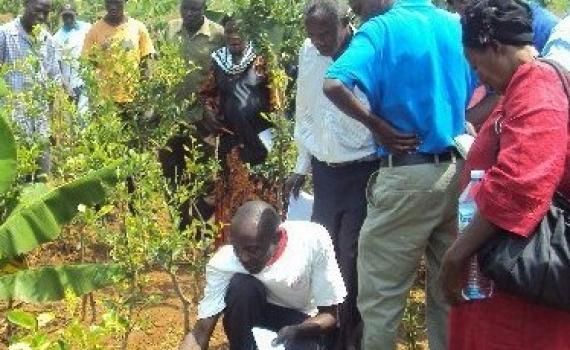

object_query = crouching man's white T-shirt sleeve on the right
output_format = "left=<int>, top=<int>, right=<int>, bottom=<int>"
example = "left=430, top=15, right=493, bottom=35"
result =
left=311, top=226, right=347, bottom=307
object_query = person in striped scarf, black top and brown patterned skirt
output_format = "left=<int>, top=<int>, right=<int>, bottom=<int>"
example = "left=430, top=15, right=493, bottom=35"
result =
left=200, top=17, right=280, bottom=244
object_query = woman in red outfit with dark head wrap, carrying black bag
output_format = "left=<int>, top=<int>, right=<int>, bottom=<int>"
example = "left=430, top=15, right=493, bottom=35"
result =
left=442, top=0, right=570, bottom=350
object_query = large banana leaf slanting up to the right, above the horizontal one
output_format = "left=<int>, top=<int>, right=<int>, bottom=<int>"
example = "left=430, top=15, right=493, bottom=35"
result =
left=0, top=166, right=118, bottom=261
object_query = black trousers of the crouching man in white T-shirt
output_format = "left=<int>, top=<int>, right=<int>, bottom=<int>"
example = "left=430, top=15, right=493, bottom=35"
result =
left=224, top=274, right=325, bottom=350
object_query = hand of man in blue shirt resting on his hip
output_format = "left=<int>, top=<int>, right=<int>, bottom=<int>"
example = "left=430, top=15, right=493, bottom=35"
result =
left=371, top=116, right=420, bottom=154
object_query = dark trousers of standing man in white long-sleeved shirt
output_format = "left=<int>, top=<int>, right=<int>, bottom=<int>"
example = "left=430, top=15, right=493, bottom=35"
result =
left=312, top=158, right=380, bottom=350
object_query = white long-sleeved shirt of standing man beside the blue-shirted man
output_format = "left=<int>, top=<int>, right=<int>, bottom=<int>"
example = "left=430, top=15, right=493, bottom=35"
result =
left=295, top=39, right=376, bottom=174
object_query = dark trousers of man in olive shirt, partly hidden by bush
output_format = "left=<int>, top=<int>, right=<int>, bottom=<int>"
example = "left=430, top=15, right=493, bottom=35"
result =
left=158, top=132, right=214, bottom=230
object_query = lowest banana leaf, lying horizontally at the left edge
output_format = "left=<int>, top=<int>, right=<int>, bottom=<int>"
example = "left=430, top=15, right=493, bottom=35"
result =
left=0, top=264, right=124, bottom=302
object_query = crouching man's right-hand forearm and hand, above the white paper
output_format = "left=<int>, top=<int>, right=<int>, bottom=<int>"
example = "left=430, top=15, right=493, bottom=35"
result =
left=274, top=305, right=337, bottom=345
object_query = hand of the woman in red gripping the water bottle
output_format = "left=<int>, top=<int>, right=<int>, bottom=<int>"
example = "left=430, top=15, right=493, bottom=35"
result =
left=439, top=244, right=469, bottom=305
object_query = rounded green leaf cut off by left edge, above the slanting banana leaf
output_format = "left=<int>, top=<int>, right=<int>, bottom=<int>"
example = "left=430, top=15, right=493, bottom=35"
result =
left=0, top=113, right=18, bottom=194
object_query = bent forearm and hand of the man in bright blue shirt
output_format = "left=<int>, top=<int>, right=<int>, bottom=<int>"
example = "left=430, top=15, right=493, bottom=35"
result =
left=323, top=79, right=419, bottom=153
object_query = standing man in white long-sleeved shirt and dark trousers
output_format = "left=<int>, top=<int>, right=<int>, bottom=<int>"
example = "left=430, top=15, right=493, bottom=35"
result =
left=285, top=0, right=379, bottom=350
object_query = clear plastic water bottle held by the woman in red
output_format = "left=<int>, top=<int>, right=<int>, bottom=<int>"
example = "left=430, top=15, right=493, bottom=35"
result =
left=457, top=170, right=494, bottom=300
